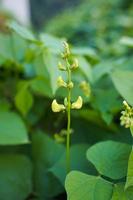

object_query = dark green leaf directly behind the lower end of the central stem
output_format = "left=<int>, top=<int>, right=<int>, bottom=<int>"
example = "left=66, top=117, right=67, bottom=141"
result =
left=49, top=144, right=96, bottom=185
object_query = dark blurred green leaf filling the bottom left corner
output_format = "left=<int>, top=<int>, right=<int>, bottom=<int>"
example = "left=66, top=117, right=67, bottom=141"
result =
left=0, top=155, right=32, bottom=200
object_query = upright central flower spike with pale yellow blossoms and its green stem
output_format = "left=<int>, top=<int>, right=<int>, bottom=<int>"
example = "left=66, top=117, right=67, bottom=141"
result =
left=52, top=42, right=83, bottom=173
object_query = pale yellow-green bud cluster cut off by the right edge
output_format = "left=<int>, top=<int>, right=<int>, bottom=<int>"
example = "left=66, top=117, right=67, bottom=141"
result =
left=120, top=101, right=133, bottom=128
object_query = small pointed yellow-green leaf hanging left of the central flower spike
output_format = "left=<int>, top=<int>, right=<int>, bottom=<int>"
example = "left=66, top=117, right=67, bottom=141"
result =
left=15, top=84, right=33, bottom=116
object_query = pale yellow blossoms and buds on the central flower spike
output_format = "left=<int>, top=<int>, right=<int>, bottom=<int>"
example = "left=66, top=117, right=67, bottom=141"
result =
left=52, top=42, right=83, bottom=112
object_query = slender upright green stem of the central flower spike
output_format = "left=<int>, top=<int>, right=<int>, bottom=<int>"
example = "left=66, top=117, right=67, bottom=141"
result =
left=66, top=59, right=71, bottom=173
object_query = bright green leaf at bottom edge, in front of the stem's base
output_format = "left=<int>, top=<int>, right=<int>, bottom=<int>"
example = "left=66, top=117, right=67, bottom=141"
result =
left=65, top=171, right=113, bottom=200
